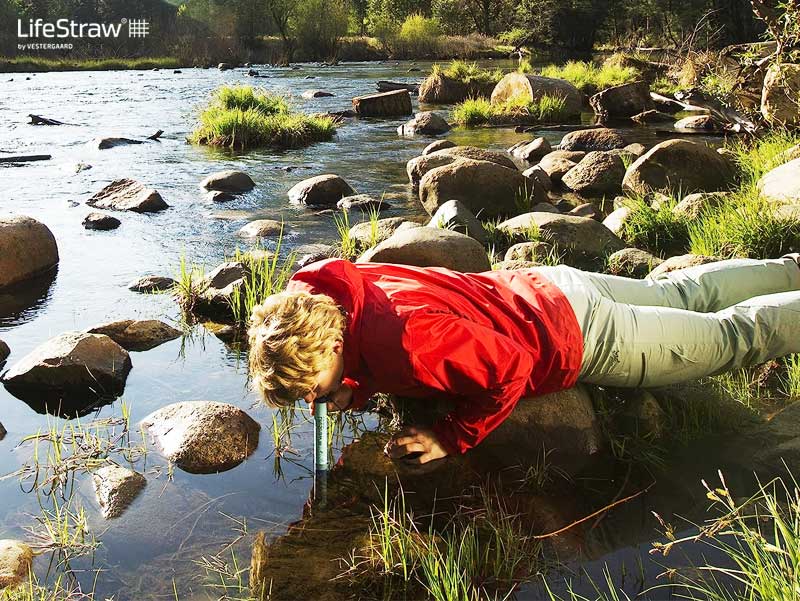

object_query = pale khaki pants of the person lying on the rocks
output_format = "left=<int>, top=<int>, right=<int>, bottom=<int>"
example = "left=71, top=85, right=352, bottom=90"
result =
left=535, top=258, right=800, bottom=387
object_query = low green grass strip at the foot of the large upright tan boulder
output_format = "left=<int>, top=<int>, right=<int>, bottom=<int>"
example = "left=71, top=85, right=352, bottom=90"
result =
left=453, top=95, right=567, bottom=126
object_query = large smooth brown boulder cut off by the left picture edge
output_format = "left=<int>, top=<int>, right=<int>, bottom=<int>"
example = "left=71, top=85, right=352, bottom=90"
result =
left=0, top=216, right=58, bottom=289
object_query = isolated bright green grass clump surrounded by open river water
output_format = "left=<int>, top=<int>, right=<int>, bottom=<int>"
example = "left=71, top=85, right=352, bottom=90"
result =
left=189, top=86, right=336, bottom=150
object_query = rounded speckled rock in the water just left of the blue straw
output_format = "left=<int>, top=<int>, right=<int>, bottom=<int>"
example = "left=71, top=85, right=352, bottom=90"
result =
left=142, top=401, right=261, bottom=474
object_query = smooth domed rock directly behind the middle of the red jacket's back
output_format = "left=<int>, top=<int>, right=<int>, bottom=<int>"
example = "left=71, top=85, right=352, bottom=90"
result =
left=358, top=227, right=491, bottom=273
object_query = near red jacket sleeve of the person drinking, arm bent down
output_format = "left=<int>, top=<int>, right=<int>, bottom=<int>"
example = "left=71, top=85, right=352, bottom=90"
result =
left=406, top=312, right=534, bottom=453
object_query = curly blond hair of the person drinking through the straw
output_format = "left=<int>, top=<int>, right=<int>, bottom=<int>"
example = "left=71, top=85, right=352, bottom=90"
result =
left=248, top=292, right=345, bottom=407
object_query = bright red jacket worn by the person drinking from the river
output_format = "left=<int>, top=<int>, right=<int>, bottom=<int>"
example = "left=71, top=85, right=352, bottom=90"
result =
left=287, top=259, right=583, bottom=453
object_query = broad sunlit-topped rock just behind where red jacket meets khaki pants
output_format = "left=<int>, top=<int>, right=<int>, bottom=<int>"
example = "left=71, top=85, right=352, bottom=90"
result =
left=497, top=213, right=625, bottom=266
